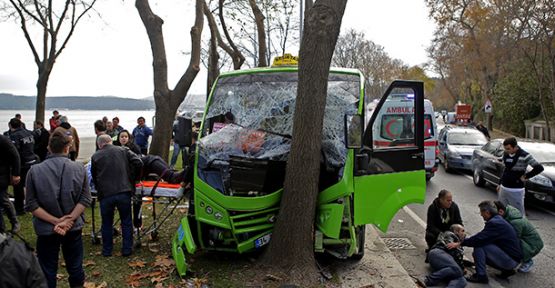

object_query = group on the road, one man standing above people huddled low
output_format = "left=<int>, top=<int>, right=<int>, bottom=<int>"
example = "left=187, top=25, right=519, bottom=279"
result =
left=421, top=137, right=543, bottom=287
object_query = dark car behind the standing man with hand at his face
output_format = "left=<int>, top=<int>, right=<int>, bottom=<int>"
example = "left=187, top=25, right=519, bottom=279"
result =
left=472, top=139, right=555, bottom=202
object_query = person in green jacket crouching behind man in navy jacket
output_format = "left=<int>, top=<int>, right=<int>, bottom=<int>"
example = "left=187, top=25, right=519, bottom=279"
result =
left=495, top=201, right=543, bottom=273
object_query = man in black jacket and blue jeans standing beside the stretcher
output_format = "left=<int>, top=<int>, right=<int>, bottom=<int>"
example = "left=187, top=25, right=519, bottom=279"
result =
left=91, top=134, right=143, bottom=257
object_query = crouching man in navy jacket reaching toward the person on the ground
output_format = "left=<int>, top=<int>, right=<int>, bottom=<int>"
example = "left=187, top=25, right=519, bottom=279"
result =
left=447, top=201, right=522, bottom=283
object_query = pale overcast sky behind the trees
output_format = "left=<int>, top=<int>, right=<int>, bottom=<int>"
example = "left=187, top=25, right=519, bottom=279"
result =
left=0, top=0, right=435, bottom=98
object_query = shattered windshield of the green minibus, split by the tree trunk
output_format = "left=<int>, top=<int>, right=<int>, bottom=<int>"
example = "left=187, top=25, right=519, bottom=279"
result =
left=199, top=72, right=360, bottom=169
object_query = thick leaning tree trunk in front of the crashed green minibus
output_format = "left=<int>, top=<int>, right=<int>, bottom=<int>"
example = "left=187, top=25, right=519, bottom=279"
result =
left=264, top=0, right=347, bottom=285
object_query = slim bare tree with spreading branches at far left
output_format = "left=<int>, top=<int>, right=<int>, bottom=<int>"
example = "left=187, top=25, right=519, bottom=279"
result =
left=6, top=0, right=96, bottom=122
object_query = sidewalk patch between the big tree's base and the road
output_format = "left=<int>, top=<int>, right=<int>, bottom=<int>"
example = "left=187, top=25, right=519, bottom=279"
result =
left=337, top=225, right=418, bottom=288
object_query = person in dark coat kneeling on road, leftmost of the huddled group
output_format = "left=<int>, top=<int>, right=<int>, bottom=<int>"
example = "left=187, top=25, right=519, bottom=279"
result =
left=426, top=189, right=463, bottom=249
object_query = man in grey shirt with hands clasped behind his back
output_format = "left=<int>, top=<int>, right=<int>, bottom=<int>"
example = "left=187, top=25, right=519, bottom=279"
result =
left=25, top=132, right=91, bottom=288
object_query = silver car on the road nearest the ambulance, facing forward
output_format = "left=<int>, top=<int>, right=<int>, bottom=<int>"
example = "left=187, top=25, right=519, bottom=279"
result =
left=438, top=125, right=488, bottom=172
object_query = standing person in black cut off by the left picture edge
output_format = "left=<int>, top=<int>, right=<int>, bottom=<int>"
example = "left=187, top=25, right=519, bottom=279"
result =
left=0, top=135, right=21, bottom=233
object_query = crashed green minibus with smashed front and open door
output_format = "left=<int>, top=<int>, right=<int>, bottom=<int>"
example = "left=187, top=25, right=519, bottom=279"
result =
left=172, top=59, right=426, bottom=276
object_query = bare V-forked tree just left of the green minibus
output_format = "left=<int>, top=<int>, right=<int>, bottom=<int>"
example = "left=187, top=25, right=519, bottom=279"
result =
left=135, top=0, right=204, bottom=160
